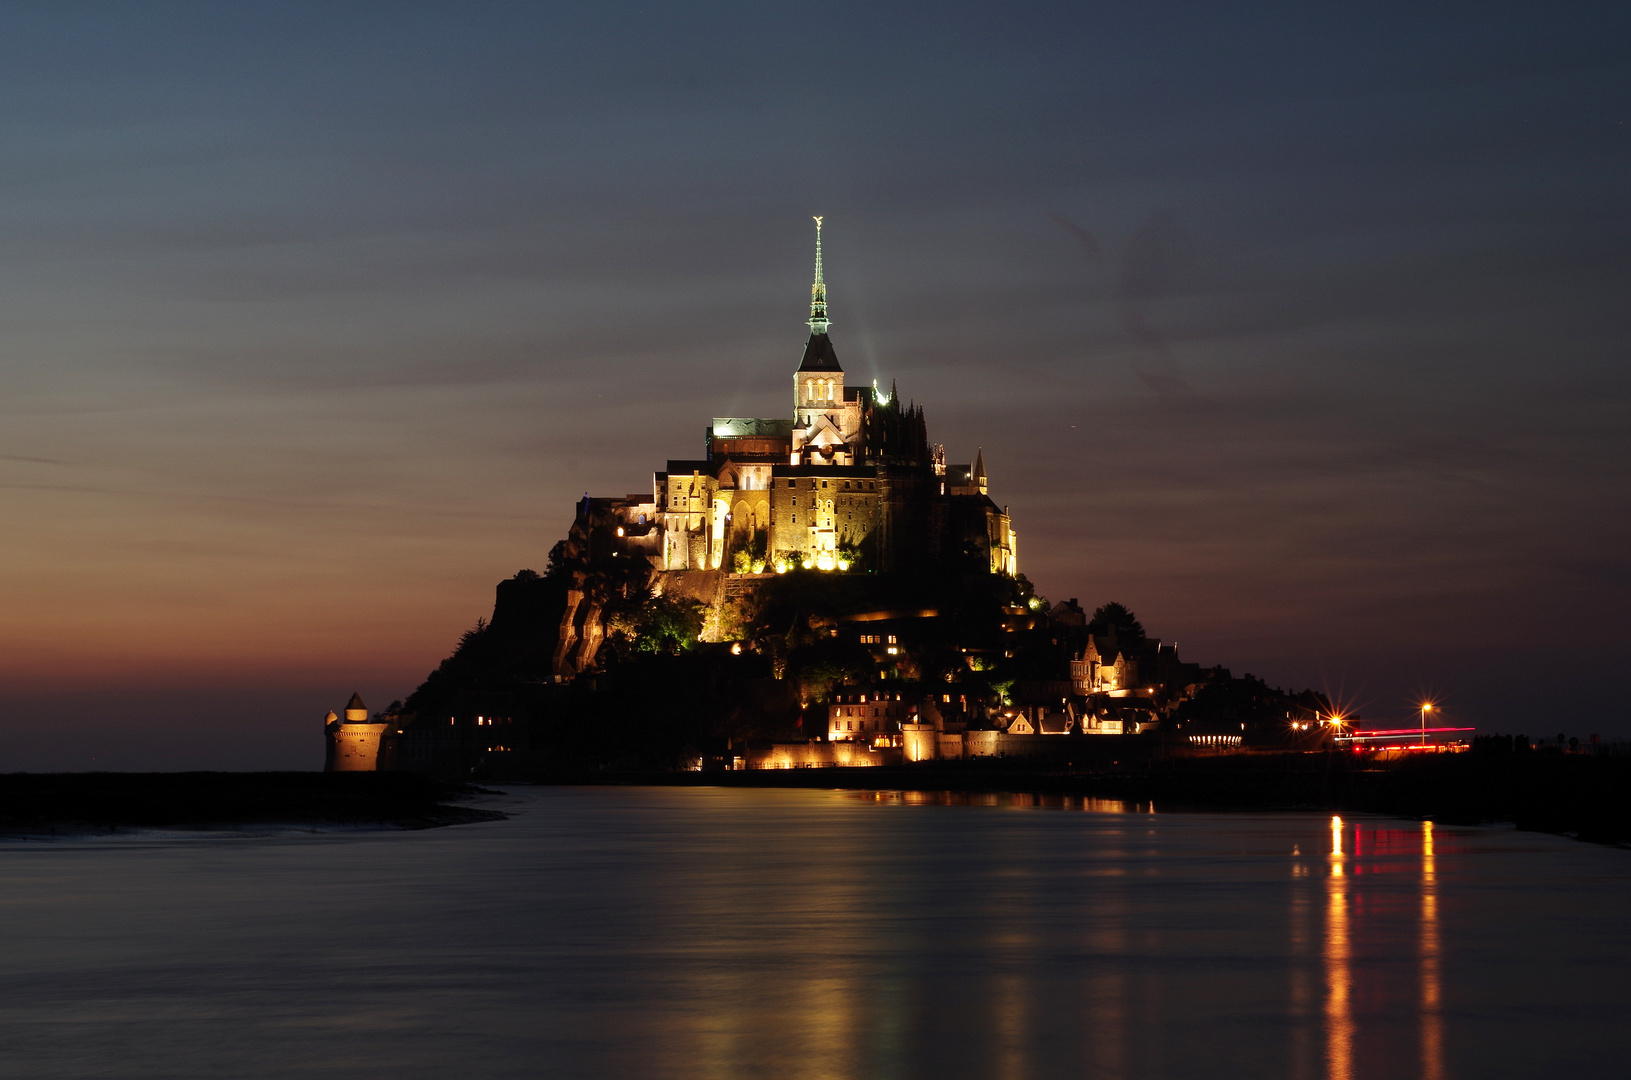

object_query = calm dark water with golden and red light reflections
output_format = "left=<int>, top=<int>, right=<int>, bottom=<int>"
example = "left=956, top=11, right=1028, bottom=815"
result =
left=0, top=788, right=1631, bottom=1080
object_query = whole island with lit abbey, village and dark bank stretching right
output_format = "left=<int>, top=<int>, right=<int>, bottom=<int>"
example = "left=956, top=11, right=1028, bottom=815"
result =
left=311, top=219, right=1621, bottom=835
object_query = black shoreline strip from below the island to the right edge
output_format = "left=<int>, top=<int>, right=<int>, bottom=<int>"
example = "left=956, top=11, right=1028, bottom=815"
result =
left=535, top=754, right=1631, bottom=845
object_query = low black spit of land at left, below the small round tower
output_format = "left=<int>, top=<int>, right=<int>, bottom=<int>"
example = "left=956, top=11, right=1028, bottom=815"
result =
left=0, top=772, right=504, bottom=835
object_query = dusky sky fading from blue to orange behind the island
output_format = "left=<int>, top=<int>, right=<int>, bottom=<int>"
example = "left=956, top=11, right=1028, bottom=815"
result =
left=0, top=2, right=1631, bottom=772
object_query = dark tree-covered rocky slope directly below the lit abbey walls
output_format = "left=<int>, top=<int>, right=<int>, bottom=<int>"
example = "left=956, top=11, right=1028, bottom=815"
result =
left=400, top=545, right=1032, bottom=775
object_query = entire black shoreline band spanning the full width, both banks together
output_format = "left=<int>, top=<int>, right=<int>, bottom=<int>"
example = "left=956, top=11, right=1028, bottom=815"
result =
left=0, top=754, right=1631, bottom=845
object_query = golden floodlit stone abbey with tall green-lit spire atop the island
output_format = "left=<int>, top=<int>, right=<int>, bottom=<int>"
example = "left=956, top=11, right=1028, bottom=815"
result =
left=572, top=217, right=1018, bottom=576
